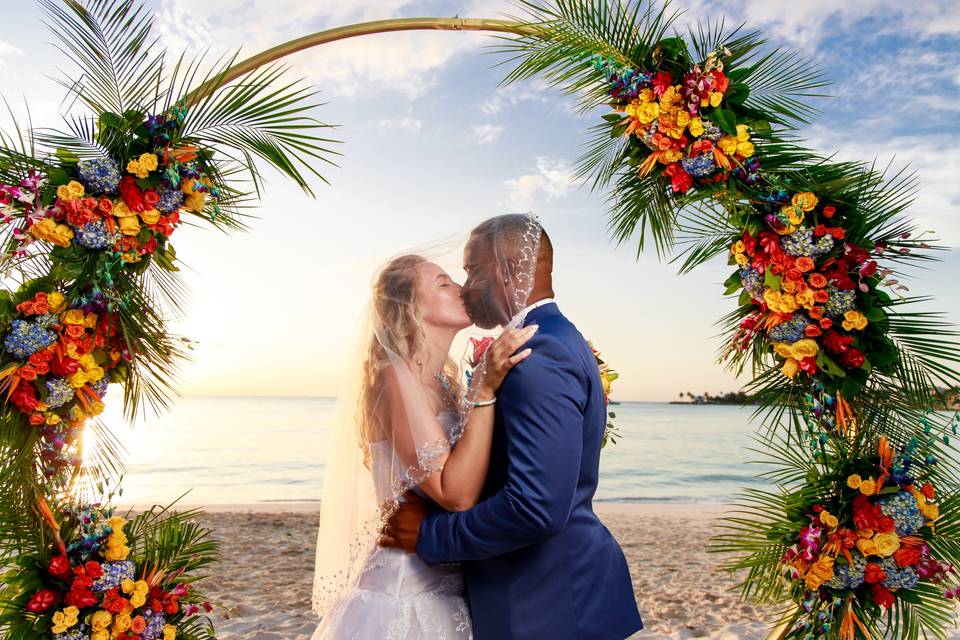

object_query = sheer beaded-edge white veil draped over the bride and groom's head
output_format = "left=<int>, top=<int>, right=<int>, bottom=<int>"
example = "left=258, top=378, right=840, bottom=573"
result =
left=312, top=214, right=542, bottom=616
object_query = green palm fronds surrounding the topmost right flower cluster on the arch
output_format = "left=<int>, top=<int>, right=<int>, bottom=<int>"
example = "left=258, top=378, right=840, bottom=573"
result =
left=492, top=0, right=829, bottom=260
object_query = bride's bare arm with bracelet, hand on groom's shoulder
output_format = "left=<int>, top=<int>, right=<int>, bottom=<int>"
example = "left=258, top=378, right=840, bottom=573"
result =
left=386, top=326, right=536, bottom=511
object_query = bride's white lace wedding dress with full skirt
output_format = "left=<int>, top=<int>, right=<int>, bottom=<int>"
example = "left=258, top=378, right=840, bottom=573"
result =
left=312, top=411, right=473, bottom=640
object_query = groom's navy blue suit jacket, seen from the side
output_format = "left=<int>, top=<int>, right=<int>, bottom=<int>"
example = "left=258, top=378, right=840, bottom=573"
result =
left=417, top=303, right=643, bottom=640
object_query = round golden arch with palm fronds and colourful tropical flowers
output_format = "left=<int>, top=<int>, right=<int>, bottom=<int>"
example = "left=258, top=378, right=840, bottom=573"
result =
left=0, top=0, right=960, bottom=640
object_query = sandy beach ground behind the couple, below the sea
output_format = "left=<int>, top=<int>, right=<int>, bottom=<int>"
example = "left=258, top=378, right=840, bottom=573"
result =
left=131, top=502, right=767, bottom=640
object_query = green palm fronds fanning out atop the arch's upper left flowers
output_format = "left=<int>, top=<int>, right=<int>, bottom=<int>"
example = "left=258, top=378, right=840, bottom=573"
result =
left=41, top=0, right=339, bottom=198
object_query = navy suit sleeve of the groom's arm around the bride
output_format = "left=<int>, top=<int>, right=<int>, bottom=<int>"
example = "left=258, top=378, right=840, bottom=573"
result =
left=417, top=334, right=587, bottom=564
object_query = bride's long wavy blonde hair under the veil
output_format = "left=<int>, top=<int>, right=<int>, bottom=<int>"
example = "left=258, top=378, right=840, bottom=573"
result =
left=358, top=254, right=460, bottom=467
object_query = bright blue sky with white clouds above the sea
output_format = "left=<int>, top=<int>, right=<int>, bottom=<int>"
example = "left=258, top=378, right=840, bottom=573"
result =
left=0, top=0, right=960, bottom=401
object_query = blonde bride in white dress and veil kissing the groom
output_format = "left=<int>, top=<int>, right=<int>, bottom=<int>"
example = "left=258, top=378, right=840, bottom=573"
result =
left=313, top=255, right=536, bottom=640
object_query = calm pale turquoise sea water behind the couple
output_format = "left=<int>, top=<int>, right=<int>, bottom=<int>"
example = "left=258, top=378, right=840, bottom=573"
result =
left=97, top=397, right=759, bottom=504
